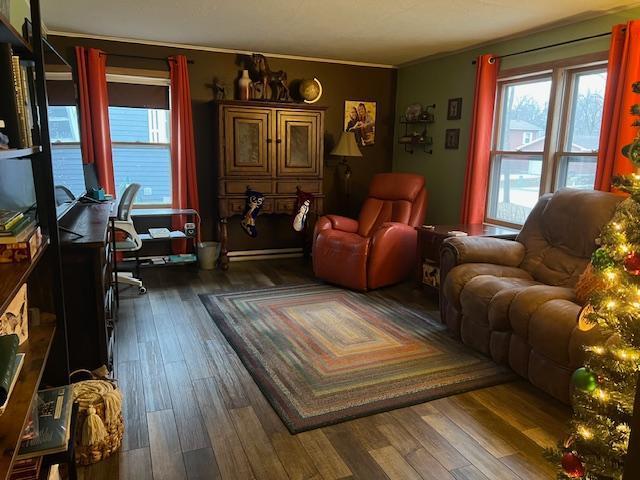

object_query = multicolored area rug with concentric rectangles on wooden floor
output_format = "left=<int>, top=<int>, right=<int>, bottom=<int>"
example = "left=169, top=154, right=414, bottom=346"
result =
left=200, top=284, right=515, bottom=433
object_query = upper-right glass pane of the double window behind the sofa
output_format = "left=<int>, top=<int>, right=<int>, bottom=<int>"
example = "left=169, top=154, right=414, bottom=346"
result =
left=565, top=70, right=607, bottom=152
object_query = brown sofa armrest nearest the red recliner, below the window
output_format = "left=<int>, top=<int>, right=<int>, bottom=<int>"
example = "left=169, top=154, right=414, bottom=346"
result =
left=440, top=237, right=525, bottom=267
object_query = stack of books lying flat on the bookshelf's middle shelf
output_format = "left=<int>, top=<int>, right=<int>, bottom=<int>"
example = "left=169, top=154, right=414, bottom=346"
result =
left=0, top=210, right=42, bottom=264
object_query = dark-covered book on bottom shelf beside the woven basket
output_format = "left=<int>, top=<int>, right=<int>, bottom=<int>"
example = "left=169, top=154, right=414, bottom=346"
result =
left=16, top=385, right=73, bottom=460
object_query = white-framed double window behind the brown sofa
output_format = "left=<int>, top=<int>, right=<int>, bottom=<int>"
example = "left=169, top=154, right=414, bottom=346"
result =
left=486, top=62, right=606, bottom=225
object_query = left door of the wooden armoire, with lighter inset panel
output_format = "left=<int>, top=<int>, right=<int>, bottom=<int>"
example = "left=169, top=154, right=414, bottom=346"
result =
left=224, top=108, right=273, bottom=176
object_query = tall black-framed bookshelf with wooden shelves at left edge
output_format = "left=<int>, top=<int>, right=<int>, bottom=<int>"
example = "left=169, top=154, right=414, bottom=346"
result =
left=0, top=0, right=69, bottom=479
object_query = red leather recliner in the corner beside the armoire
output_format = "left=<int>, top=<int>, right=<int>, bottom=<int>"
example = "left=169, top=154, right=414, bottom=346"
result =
left=313, top=173, right=427, bottom=290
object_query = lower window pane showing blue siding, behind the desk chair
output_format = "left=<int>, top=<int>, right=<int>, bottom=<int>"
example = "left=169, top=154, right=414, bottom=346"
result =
left=113, top=145, right=171, bottom=205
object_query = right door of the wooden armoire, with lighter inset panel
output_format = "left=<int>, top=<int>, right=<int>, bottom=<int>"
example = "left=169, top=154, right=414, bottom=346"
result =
left=276, top=110, right=322, bottom=176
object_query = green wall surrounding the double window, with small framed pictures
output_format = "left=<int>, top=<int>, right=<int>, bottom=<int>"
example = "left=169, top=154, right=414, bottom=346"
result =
left=393, top=7, right=640, bottom=224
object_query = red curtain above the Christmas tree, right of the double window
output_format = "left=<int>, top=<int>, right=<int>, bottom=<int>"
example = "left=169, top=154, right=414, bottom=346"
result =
left=595, top=20, right=640, bottom=192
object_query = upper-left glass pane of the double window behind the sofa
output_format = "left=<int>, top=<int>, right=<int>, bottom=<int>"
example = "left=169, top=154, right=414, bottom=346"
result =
left=498, top=78, right=551, bottom=152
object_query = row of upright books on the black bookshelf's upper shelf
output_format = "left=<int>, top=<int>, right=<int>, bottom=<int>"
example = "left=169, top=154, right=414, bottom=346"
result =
left=0, top=43, right=38, bottom=148
